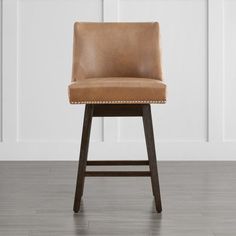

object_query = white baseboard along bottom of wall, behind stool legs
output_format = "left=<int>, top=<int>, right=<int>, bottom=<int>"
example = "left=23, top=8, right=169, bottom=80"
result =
left=0, top=142, right=236, bottom=161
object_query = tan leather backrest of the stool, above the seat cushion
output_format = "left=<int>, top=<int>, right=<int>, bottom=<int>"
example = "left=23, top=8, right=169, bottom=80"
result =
left=72, top=22, right=162, bottom=81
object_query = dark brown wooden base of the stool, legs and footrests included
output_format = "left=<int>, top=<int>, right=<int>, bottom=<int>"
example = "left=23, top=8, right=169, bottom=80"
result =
left=74, top=104, right=162, bottom=213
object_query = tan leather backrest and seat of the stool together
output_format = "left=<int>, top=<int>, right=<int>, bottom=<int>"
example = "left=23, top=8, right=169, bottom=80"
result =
left=69, top=23, right=166, bottom=103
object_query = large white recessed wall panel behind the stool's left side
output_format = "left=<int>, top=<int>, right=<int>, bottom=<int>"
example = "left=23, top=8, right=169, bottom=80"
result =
left=18, top=0, right=102, bottom=142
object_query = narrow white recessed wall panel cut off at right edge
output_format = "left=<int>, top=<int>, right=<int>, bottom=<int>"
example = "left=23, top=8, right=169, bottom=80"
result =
left=224, top=0, right=236, bottom=141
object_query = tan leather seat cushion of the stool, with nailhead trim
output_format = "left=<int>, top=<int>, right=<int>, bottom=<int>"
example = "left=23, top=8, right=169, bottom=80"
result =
left=69, top=77, right=166, bottom=104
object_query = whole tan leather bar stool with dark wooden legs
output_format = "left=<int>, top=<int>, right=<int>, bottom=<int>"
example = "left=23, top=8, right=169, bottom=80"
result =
left=69, top=22, right=166, bottom=212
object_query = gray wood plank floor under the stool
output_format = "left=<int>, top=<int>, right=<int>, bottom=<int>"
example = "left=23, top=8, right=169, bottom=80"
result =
left=0, top=162, right=236, bottom=236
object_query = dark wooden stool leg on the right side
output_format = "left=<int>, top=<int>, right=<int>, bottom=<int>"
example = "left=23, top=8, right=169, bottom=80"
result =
left=142, top=104, right=162, bottom=212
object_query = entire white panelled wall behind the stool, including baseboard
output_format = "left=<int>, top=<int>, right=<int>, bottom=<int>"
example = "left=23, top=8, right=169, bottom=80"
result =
left=0, top=0, right=236, bottom=160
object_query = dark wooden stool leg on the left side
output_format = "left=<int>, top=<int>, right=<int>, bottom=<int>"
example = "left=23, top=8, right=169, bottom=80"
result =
left=74, top=105, right=94, bottom=213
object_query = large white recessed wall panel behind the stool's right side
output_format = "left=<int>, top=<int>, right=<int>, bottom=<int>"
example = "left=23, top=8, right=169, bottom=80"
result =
left=119, top=0, right=208, bottom=141
